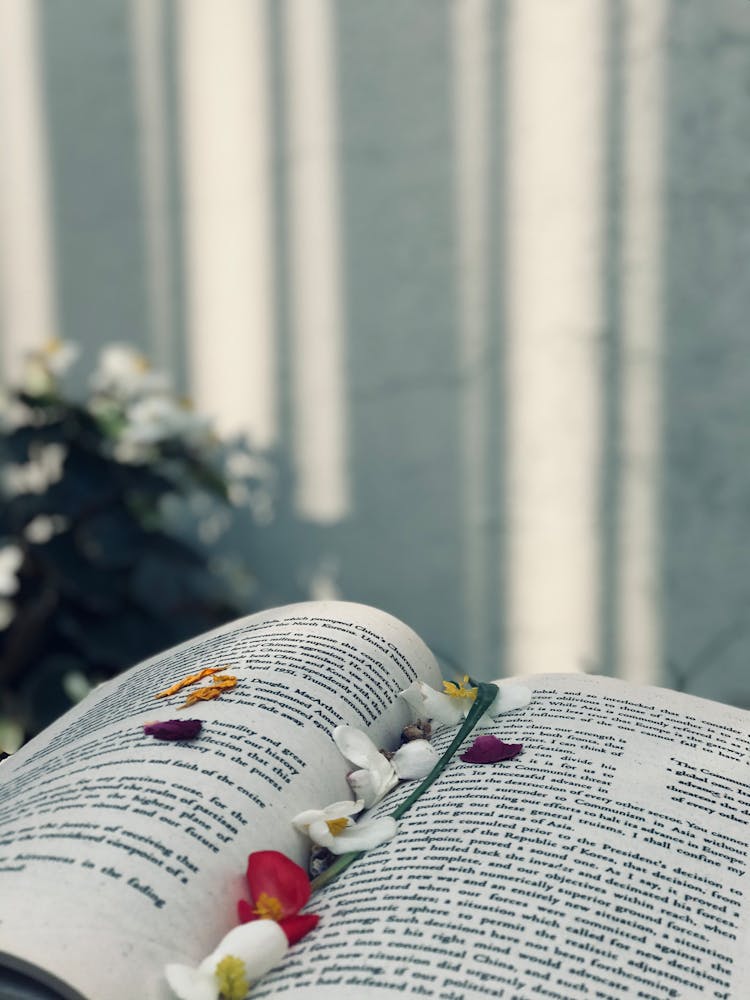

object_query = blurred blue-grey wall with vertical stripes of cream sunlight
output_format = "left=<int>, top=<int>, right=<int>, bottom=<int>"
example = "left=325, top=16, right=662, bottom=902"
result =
left=0, top=0, right=750, bottom=705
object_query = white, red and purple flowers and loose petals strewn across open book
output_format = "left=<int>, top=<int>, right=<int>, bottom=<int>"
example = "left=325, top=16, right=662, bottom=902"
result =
left=162, top=675, right=531, bottom=1000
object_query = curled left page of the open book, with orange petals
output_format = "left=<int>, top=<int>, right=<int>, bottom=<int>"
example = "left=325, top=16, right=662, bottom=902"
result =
left=0, top=602, right=439, bottom=1000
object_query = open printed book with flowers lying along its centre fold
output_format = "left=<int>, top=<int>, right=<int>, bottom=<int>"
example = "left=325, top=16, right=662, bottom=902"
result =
left=0, top=602, right=750, bottom=1000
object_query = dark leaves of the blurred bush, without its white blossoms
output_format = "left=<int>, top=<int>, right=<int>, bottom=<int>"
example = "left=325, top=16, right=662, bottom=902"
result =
left=0, top=344, right=262, bottom=737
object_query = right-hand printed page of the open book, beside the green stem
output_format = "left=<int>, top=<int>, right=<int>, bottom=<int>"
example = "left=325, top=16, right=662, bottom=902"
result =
left=253, top=675, right=750, bottom=1000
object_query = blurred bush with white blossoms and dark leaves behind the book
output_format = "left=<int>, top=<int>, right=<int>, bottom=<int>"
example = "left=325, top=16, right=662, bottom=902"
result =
left=0, top=341, right=270, bottom=749
